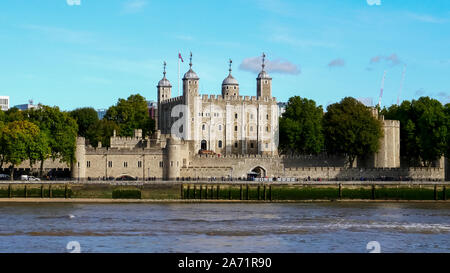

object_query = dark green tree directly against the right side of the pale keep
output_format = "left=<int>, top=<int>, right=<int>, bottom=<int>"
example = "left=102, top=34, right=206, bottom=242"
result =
left=280, top=96, right=324, bottom=154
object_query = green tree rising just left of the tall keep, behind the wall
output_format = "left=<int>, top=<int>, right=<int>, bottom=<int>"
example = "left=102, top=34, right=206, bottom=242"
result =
left=104, top=94, right=155, bottom=136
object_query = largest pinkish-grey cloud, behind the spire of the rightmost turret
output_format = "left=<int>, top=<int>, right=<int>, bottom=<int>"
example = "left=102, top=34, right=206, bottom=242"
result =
left=239, top=57, right=300, bottom=75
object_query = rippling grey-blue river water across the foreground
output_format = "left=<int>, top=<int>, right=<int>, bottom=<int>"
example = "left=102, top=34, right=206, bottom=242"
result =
left=0, top=202, right=450, bottom=253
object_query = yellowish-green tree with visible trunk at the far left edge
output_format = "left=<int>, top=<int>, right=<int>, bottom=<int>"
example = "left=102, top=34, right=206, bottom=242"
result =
left=0, top=120, right=39, bottom=180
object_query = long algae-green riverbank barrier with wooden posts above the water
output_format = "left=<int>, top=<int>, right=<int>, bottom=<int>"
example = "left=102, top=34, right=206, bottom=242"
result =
left=0, top=182, right=450, bottom=202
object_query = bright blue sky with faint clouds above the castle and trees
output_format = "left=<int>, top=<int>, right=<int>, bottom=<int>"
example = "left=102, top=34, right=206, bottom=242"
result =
left=0, top=0, right=450, bottom=110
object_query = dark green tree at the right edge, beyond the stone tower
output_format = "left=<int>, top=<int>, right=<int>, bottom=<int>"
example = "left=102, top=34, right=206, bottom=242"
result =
left=382, top=97, right=449, bottom=166
